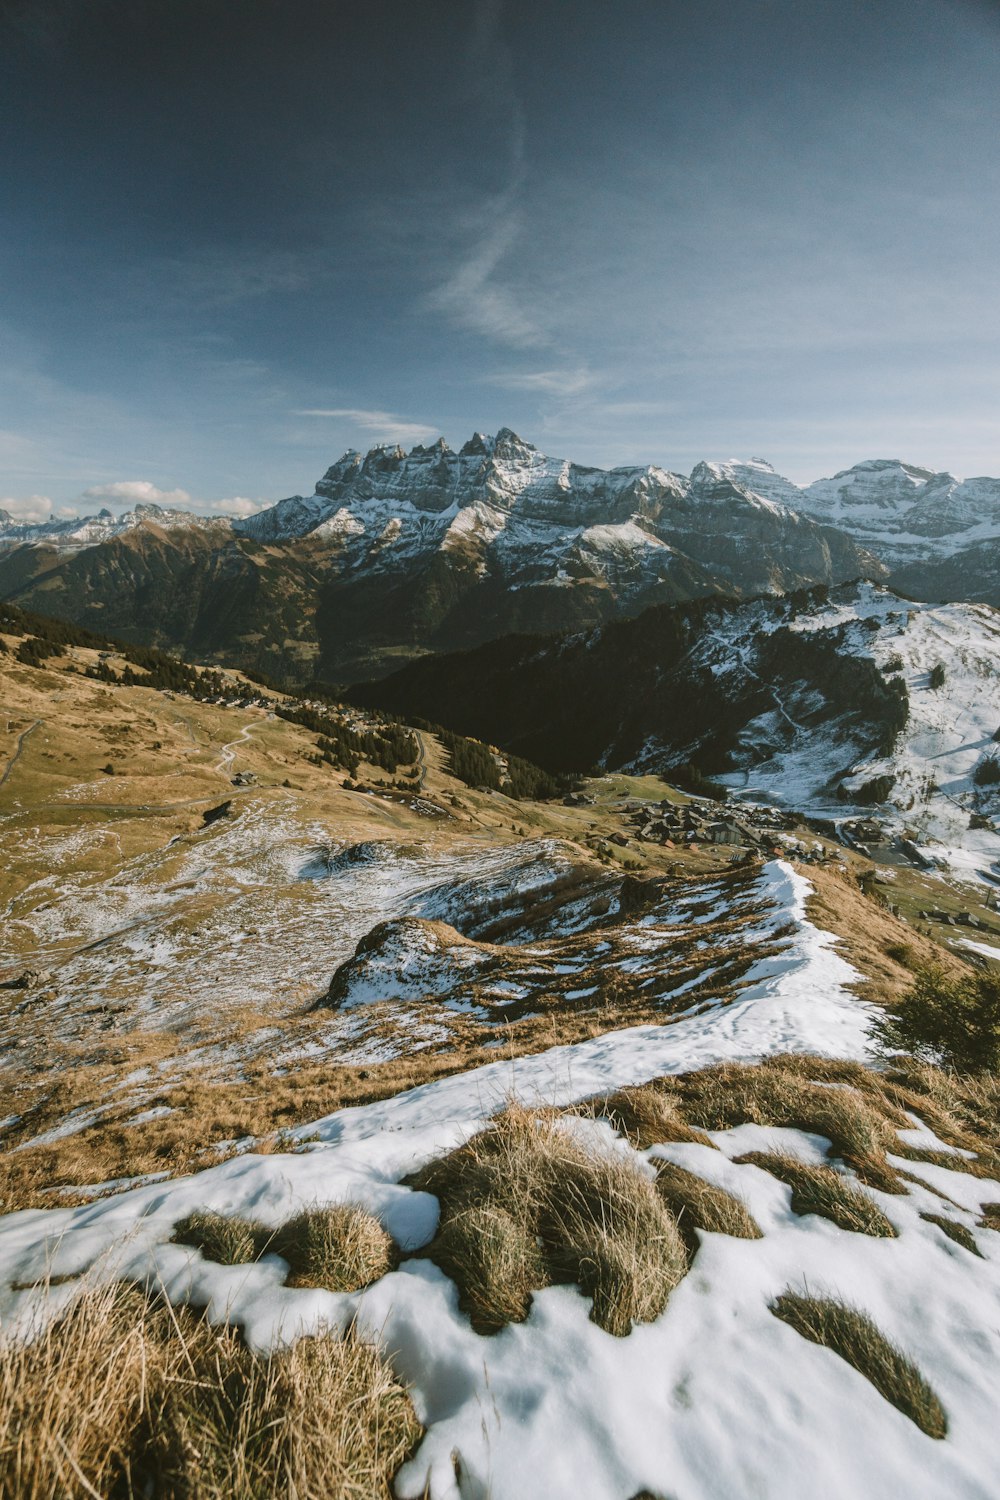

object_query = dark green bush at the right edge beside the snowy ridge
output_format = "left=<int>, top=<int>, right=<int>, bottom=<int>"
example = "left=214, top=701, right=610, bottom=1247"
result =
left=871, top=965, right=1000, bottom=1073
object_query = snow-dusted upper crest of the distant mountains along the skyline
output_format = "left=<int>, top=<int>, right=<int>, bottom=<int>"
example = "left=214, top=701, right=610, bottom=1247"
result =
left=0, top=428, right=1000, bottom=566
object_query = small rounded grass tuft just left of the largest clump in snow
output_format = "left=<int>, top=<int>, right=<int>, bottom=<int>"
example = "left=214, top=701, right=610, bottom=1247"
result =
left=268, top=1203, right=399, bottom=1292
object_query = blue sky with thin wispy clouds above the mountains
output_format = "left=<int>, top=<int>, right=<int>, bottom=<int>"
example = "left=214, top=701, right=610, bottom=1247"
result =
left=0, top=0, right=1000, bottom=518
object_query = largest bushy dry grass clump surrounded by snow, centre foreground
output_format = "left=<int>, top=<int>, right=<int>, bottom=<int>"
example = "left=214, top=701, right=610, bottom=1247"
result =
left=411, top=1106, right=687, bottom=1337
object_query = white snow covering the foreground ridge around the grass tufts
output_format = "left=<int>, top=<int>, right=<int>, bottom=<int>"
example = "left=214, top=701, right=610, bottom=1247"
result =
left=0, top=863, right=1000, bottom=1500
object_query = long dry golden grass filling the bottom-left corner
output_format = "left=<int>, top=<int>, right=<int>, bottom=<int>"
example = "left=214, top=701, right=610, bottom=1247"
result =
left=0, top=1286, right=421, bottom=1500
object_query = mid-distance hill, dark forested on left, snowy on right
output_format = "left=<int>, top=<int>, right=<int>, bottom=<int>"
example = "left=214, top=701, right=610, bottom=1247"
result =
left=354, top=584, right=1000, bottom=873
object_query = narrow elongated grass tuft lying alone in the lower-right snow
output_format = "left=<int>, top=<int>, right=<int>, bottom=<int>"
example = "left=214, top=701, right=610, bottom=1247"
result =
left=771, top=1290, right=948, bottom=1439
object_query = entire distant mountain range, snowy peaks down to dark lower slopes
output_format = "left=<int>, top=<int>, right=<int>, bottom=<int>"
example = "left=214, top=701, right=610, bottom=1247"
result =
left=0, top=428, right=1000, bottom=683
